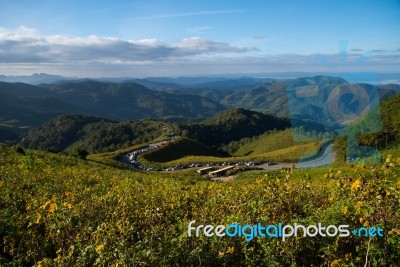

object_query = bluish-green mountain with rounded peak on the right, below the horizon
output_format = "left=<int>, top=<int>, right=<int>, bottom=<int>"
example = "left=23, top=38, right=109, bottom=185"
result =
left=154, top=75, right=400, bottom=117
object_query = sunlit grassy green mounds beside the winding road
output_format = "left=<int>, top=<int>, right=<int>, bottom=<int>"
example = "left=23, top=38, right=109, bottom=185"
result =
left=87, top=129, right=322, bottom=168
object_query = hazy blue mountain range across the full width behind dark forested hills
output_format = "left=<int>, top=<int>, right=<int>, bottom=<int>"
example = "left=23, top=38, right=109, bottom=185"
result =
left=0, top=74, right=400, bottom=146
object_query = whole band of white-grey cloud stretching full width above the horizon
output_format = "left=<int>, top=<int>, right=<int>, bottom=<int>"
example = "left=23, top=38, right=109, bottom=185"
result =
left=0, top=26, right=400, bottom=77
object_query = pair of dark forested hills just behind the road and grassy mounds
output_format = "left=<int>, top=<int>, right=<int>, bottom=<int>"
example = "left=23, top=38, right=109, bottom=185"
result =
left=21, top=109, right=289, bottom=155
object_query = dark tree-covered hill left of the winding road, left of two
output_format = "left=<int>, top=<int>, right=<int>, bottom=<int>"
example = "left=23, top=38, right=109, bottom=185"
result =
left=22, top=115, right=164, bottom=153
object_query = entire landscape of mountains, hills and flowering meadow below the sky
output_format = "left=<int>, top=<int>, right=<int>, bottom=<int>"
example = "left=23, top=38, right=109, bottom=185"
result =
left=0, top=76, right=400, bottom=266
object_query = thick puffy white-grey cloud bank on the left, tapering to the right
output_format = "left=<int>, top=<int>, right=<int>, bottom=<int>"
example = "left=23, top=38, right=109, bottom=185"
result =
left=0, top=27, right=255, bottom=64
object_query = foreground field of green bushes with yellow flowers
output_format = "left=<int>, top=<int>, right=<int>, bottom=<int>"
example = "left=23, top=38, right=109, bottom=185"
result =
left=0, top=145, right=400, bottom=266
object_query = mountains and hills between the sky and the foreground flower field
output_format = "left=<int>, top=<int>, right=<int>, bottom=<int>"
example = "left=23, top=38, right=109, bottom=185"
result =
left=0, top=76, right=400, bottom=169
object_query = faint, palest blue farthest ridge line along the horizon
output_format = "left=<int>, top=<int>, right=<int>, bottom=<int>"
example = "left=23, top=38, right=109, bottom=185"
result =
left=0, top=72, right=400, bottom=85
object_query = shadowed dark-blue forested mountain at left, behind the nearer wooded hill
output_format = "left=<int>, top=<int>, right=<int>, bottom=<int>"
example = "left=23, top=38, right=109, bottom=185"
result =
left=0, top=80, right=224, bottom=127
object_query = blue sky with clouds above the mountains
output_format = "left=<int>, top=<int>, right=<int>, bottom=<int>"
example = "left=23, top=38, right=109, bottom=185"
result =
left=0, top=0, right=400, bottom=77
